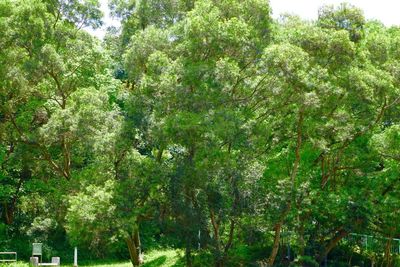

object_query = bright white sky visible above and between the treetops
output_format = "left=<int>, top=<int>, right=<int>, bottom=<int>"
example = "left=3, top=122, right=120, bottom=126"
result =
left=87, top=0, right=400, bottom=39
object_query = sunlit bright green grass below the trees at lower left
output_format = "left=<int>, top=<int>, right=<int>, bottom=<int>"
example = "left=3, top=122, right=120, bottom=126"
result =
left=0, top=249, right=184, bottom=267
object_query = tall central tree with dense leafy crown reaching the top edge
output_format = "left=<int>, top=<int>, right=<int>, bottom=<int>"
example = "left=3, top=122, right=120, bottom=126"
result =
left=122, top=1, right=270, bottom=266
